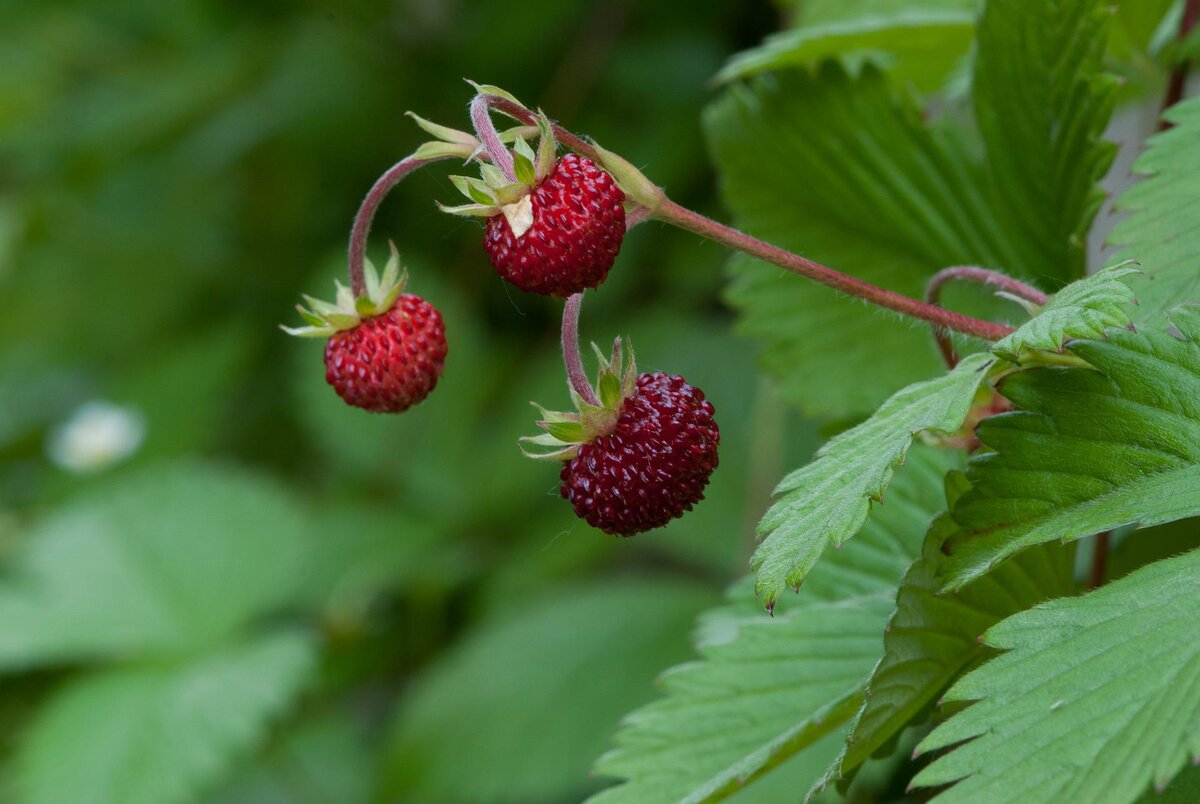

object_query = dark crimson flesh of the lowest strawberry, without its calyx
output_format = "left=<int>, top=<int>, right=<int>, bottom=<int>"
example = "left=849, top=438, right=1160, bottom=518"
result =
left=560, top=373, right=721, bottom=536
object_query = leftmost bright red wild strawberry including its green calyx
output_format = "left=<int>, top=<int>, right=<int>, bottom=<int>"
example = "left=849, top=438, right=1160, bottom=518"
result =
left=283, top=247, right=446, bottom=413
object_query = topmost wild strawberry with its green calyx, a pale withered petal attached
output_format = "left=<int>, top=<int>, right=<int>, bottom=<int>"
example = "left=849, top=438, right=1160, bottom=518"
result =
left=443, top=118, right=625, bottom=296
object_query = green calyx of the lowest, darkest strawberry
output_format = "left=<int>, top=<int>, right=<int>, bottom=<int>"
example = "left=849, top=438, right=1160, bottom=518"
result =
left=517, top=337, right=637, bottom=461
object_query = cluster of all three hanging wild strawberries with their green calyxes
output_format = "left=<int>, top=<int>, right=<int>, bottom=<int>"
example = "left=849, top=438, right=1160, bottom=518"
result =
left=284, top=96, right=720, bottom=536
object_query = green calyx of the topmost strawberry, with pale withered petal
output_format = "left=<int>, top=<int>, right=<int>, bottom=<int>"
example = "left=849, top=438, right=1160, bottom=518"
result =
left=438, top=110, right=558, bottom=238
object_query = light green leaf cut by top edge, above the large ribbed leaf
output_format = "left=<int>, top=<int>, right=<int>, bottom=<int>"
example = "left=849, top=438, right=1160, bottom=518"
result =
left=715, top=0, right=976, bottom=90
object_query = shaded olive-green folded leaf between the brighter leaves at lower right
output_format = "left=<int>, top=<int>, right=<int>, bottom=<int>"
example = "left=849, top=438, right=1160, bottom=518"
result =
left=821, top=517, right=1074, bottom=787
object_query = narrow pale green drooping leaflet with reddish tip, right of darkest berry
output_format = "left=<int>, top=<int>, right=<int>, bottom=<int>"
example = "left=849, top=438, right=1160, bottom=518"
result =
left=750, top=354, right=992, bottom=608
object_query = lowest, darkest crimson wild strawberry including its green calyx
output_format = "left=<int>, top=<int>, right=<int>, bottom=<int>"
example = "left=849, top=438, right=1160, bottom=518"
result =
left=526, top=338, right=721, bottom=536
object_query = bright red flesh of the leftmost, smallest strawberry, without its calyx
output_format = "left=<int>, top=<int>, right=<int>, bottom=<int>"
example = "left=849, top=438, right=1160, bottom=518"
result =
left=325, top=293, right=446, bottom=413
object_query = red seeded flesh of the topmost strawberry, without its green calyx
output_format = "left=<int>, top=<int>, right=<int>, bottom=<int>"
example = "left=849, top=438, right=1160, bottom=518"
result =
left=484, top=154, right=625, bottom=296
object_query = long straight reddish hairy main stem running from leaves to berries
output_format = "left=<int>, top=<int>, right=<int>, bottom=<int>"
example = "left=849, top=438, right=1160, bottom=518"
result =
left=472, top=95, right=1013, bottom=341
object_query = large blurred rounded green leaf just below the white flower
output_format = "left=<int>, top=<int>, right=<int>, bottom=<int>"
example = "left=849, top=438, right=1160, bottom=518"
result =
left=0, top=463, right=305, bottom=667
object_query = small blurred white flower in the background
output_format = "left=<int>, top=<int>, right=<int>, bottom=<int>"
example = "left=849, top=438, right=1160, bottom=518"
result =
left=46, top=400, right=145, bottom=474
